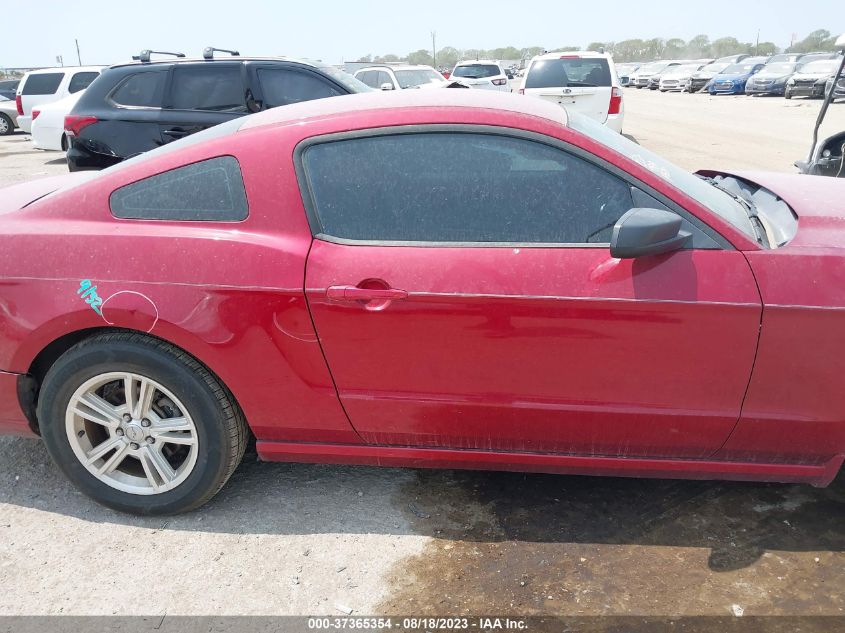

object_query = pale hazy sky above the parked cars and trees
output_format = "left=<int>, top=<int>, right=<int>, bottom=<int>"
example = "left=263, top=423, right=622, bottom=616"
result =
left=0, top=0, right=845, bottom=68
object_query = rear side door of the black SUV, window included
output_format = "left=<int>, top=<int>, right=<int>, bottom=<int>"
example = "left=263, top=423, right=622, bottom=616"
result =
left=159, top=62, right=248, bottom=143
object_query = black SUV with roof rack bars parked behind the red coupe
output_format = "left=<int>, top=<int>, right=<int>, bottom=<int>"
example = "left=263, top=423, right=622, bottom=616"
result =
left=65, top=49, right=372, bottom=171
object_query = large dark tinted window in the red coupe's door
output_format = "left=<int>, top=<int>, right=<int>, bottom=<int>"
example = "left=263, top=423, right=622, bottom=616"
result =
left=303, top=133, right=632, bottom=243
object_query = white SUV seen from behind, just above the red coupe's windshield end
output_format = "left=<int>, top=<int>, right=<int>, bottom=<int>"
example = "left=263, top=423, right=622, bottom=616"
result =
left=519, top=51, right=625, bottom=133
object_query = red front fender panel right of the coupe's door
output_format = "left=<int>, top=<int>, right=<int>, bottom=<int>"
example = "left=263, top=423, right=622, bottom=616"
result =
left=716, top=246, right=845, bottom=463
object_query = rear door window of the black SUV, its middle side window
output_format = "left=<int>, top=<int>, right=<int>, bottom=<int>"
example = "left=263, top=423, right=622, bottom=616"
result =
left=171, top=63, right=247, bottom=112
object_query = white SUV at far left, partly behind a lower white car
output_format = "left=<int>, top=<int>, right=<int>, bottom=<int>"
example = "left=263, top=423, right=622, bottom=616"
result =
left=15, top=66, right=103, bottom=134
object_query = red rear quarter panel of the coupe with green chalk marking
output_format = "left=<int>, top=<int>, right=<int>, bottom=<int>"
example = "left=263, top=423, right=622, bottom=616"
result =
left=0, top=127, right=360, bottom=443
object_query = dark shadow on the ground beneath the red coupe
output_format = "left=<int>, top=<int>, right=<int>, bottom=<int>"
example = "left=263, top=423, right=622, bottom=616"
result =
left=0, top=438, right=845, bottom=572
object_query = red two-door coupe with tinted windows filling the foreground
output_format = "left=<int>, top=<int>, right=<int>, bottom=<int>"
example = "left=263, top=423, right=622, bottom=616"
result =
left=0, top=90, right=845, bottom=514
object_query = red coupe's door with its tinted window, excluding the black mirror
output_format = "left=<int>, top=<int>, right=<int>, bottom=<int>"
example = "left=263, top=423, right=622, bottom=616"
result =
left=298, top=128, right=761, bottom=457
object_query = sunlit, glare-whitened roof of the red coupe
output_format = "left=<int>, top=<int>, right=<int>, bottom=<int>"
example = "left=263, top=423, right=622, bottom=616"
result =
left=239, top=88, right=568, bottom=130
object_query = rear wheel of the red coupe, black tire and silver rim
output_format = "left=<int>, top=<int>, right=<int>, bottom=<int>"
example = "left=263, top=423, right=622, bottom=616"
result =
left=37, top=332, right=249, bottom=515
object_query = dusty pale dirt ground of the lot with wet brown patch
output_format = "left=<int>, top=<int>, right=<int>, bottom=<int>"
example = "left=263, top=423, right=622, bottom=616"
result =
left=0, top=89, right=845, bottom=616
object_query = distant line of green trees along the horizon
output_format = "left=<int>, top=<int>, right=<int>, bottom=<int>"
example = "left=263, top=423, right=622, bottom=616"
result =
left=358, top=29, right=836, bottom=68
